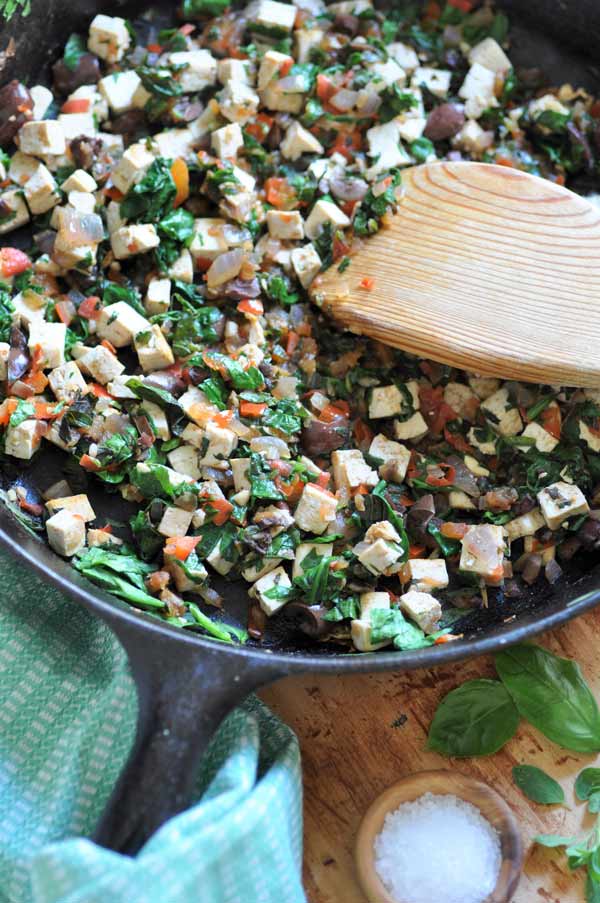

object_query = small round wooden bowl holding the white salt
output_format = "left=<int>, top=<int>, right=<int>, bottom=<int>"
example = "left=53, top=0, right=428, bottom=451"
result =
left=355, top=769, right=523, bottom=903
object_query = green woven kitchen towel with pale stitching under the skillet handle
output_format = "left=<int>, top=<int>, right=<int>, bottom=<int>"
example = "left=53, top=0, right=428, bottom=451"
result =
left=0, top=555, right=305, bottom=903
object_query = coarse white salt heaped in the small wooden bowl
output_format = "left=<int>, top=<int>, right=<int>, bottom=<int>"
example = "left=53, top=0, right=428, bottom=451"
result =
left=375, top=793, right=502, bottom=903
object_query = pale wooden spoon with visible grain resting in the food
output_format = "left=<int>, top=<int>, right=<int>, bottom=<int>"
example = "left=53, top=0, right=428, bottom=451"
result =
left=310, top=163, right=600, bottom=386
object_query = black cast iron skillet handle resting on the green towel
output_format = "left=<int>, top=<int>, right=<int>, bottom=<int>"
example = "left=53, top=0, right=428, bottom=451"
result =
left=94, top=624, right=283, bottom=855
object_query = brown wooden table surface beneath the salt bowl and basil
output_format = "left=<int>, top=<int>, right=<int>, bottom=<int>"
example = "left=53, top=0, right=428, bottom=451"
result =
left=261, top=609, right=600, bottom=903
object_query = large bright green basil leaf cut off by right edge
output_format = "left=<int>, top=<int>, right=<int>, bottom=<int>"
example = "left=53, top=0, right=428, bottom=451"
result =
left=495, top=645, right=600, bottom=753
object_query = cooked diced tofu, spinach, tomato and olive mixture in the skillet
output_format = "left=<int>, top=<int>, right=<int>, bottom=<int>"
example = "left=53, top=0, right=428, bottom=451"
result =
left=0, top=0, right=600, bottom=652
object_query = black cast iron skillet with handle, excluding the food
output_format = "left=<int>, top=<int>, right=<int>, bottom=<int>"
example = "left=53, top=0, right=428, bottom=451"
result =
left=0, top=0, right=600, bottom=853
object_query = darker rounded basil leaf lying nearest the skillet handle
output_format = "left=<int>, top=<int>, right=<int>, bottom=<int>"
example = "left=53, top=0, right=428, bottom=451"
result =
left=427, top=679, right=519, bottom=756
